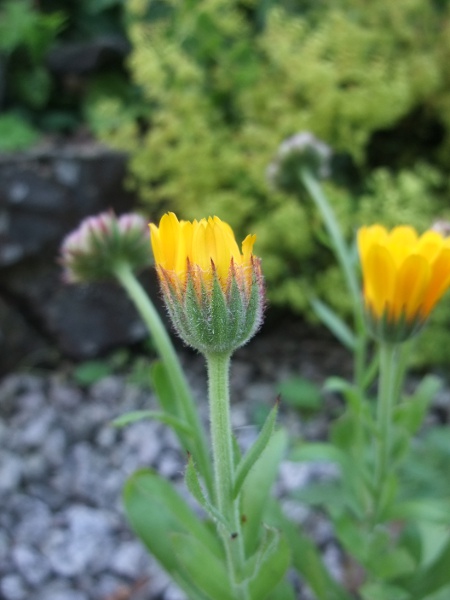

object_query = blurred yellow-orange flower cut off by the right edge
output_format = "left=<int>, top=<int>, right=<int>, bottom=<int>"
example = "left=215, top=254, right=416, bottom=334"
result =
left=358, top=225, right=450, bottom=342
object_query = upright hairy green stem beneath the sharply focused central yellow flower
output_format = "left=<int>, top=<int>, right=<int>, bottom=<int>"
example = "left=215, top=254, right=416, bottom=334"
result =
left=206, top=354, right=248, bottom=600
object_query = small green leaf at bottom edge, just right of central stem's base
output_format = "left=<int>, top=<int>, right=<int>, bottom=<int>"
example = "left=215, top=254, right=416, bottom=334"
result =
left=244, top=529, right=290, bottom=600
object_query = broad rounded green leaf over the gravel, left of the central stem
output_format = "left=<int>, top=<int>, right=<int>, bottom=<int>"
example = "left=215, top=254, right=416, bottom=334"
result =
left=123, top=469, right=223, bottom=576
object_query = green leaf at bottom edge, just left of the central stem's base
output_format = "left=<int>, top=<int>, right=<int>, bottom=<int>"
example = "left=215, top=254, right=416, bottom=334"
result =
left=171, top=533, right=236, bottom=600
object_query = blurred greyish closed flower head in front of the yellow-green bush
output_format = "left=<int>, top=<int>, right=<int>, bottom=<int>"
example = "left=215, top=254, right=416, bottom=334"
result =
left=267, top=131, right=331, bottom=192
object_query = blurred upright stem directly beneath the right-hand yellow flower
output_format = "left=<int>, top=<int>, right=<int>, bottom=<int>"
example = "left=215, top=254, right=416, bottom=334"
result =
left=375, top=343, right=399, bottom=518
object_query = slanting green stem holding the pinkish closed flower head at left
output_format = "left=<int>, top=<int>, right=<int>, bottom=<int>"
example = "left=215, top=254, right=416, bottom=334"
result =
left=115, top=263, right=213, bottom=497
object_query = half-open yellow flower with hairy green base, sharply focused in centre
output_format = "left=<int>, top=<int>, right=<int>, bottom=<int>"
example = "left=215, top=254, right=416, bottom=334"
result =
left=150, top=213, right=264, bottom=354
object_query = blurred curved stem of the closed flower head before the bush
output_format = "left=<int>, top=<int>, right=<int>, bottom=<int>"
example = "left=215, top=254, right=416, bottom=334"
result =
left=300, top=168, right=367, bottom=393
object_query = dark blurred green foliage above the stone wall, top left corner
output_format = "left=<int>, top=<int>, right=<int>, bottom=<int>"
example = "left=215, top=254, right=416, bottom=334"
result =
left=0, top=0, right=134, bottom=152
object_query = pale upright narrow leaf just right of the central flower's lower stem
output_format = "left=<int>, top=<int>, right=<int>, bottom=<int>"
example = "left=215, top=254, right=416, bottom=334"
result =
left=242, top=429, right=288, bottom=556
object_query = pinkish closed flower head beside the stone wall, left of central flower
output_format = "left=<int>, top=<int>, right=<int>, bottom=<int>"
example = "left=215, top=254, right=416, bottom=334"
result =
left=60, top=211, right=151, bottom=283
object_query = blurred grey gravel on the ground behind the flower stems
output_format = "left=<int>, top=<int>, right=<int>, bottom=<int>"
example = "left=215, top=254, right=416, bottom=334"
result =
left=0, top=326, right=352, bottom=600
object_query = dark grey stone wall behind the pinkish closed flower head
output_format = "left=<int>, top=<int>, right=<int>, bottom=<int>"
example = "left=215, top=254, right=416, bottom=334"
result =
left=0, top=144, right=154, bottom=374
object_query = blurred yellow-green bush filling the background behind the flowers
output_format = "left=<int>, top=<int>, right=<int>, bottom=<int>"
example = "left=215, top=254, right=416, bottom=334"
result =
left=91, top=0, right=450, bottom=360
